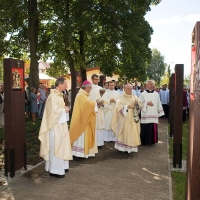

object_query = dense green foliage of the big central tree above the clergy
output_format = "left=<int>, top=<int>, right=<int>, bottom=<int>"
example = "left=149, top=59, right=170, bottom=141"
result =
left=41, top=0, right=162, bottom=80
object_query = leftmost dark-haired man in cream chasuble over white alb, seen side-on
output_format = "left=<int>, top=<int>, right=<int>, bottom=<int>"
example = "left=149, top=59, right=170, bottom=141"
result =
left=38, top=78, right=72, bottom=178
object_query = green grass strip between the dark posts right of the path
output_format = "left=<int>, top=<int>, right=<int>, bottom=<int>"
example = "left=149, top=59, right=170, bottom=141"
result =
left=169, top=121, right=189, bottom=200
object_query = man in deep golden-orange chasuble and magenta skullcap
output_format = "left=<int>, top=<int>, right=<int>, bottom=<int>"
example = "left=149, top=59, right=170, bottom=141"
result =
left=69, top=80, right=98, bottom=160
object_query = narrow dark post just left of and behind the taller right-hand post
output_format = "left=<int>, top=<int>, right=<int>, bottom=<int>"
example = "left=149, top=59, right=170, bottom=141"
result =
left=169, top=73, right=175, bottom=137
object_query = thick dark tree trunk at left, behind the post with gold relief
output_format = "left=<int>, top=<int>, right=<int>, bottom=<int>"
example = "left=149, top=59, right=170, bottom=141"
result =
left=28, top=0, right=39, bottom=88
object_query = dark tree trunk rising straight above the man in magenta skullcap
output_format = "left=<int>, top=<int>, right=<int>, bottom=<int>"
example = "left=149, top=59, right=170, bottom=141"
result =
left=79, top=31, right=87, bottom=82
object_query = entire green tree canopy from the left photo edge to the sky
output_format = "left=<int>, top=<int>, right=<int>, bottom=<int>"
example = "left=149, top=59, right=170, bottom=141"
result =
left=0, top=0, right=160, bottom=85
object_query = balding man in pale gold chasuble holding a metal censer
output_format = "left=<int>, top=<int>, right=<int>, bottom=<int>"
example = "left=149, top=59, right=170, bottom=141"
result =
left=111, top=84, right=142, bottom=153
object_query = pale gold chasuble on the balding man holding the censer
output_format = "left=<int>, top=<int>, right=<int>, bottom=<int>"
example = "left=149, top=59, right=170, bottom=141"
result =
left=111, top=92, right=142, bottom=146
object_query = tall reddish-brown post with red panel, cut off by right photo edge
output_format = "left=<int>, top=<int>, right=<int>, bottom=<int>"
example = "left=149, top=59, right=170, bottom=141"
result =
left=186, top=22, right=200, bottom=200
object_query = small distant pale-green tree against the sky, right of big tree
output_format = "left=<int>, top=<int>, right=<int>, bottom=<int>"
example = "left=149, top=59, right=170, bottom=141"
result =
left=147, top=49, right=169, bottom=85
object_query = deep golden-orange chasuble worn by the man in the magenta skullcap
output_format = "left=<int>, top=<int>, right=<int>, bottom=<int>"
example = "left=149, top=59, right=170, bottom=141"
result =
left=69, top=89, right=96, bottom=155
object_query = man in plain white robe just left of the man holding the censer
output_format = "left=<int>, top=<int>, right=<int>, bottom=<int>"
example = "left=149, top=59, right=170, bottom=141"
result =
left=104, top=81, right=120, bottom=142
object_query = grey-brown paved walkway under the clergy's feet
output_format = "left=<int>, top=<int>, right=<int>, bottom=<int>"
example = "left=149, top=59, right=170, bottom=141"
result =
left=0, top=119, right=171, bottom=200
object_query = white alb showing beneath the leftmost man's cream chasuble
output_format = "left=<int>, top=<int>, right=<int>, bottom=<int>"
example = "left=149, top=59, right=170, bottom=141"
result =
left=45, top=110, right=69, bottom=175
